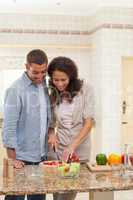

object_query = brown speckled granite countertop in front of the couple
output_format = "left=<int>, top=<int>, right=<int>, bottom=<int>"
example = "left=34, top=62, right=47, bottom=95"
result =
left=0, top=165, right=133, bottom=195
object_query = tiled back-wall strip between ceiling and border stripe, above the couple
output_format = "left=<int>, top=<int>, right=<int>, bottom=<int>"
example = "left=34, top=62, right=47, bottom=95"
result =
left=0, top=14, right=89, bottom=31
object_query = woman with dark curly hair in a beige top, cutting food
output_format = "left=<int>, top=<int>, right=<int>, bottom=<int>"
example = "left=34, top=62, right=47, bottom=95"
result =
left=48, top=57, right=94, bottom=200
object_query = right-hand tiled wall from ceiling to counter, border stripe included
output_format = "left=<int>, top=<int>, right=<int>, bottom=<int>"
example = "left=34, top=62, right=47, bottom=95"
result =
left=91, top=8, right=133, bottom=156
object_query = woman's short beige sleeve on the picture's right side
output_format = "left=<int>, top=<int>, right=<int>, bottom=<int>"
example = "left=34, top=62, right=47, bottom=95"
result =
left=83, top=84, right=95, bottom=120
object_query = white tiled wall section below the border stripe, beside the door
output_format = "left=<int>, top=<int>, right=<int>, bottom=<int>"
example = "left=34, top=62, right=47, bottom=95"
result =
left=102, top=29, right=133, bottom=151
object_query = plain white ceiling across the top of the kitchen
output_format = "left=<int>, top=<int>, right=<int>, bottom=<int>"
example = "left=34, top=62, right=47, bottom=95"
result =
left=0, top=0, right=133, bottom=15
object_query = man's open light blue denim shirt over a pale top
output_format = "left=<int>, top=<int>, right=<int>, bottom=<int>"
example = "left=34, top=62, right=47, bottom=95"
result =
left=2, top=73, right=51, bottom=162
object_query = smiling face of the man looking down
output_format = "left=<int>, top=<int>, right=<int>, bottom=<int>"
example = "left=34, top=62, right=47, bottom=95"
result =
left=26, top=63, right=47, bottom=84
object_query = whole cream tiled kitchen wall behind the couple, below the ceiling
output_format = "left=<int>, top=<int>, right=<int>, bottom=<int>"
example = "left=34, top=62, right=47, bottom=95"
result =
left=0, top=8, right=133, bottom=159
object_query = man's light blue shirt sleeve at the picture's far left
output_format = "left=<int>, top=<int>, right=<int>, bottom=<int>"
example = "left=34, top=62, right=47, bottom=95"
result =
left=2, top=88, right=21, bottom=148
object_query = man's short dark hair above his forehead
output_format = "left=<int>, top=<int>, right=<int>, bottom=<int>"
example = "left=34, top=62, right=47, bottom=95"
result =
left=26, top=49, right=48, bottom=65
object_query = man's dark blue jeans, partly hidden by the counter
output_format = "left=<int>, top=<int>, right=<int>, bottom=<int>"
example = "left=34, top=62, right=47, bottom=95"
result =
left=5, top=158, right=46, bottom=200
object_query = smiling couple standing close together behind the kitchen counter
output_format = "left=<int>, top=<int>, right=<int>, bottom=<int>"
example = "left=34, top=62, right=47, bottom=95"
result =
left=2, top=49, right=94, bottom=200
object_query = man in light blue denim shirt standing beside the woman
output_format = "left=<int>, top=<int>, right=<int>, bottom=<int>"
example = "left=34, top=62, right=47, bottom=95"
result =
left=3, top=49, right=51, bottom=200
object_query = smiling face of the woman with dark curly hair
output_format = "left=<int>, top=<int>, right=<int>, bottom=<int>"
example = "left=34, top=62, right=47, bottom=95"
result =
left=52, top=70, right=69, bottom=92
